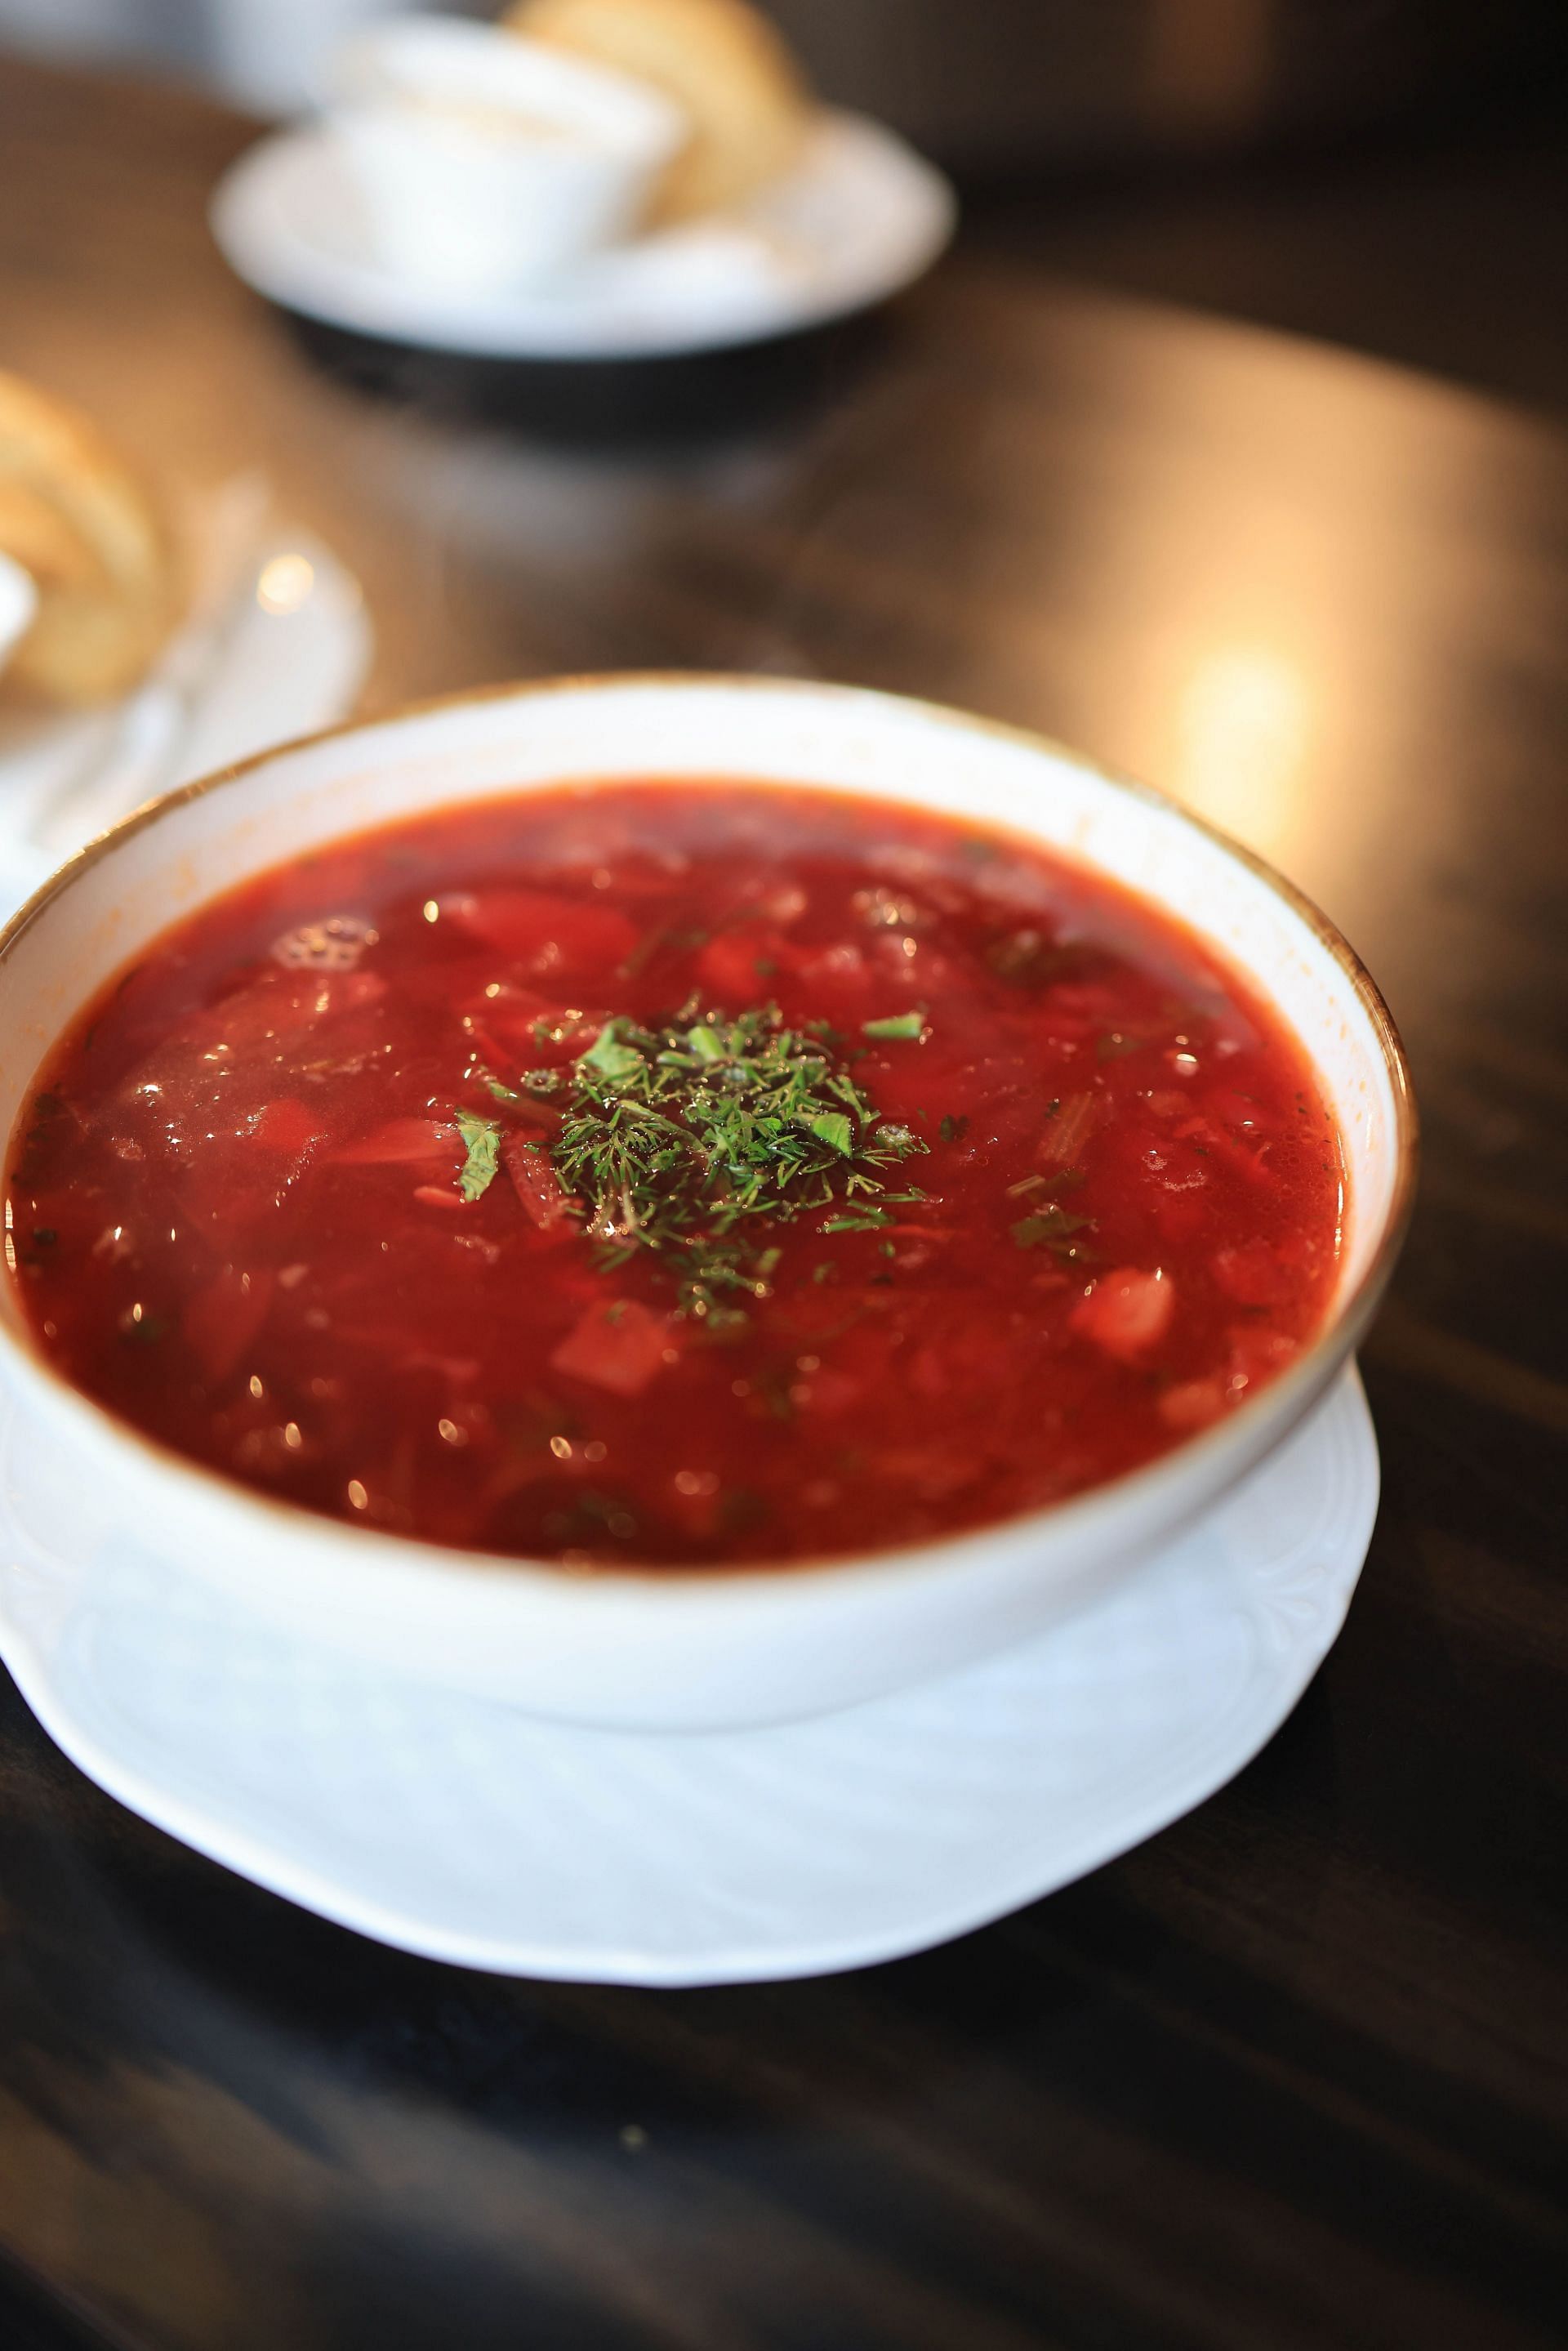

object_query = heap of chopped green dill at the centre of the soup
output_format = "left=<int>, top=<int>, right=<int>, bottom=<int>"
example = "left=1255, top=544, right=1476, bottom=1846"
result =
left=512, top=1002, right=926, bottom=1323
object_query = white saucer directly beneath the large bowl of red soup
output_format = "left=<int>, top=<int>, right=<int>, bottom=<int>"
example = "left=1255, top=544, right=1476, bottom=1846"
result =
left=0, top=1366, right=1378, bottom=1984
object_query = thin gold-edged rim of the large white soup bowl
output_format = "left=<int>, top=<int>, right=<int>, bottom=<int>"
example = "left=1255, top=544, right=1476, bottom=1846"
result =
left=0, top=670, right=1420, bottom=1596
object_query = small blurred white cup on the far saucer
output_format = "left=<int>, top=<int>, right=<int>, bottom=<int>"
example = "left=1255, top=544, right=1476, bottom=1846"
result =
left=327, top=16, right=684, bottom=292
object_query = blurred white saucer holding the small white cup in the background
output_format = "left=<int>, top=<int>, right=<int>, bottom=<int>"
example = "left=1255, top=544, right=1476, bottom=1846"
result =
left=212, top=113, right=957, bottom=359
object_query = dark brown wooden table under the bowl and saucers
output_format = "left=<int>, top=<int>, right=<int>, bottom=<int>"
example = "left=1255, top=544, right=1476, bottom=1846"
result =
left=0, top=64, right=1568, bottom=2351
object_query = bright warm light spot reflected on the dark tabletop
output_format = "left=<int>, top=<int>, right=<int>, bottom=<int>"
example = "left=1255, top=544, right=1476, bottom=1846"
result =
left=1173, top=645, right=1309, bottom=856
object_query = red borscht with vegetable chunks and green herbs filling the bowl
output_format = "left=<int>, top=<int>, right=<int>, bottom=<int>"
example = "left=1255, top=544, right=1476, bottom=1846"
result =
left=7, top=783, right=1345, bottom=1566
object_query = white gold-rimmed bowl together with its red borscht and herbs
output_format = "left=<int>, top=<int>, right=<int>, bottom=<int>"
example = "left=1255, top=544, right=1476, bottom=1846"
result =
left=0, top=675, right=1415, bottom=1728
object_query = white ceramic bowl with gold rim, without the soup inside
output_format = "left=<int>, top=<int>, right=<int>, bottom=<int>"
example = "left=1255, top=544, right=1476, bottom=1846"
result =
left=0, top=675, right=1415, bottom=1728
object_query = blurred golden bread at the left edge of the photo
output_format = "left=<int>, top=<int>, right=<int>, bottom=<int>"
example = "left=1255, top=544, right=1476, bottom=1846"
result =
left=0, top=372, right=176, bottom=703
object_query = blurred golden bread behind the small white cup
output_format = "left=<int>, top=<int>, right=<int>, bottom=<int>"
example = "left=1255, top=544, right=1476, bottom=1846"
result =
left=503, top=0, right=811, bottom=221
